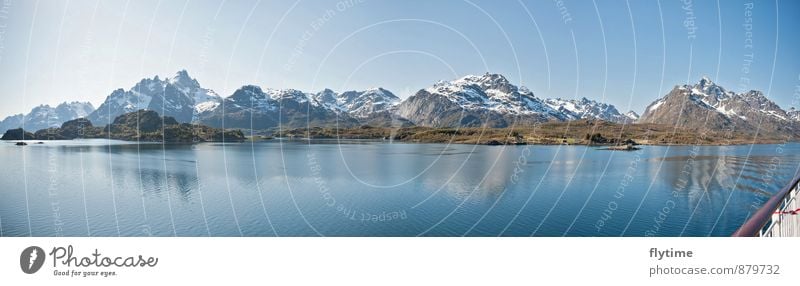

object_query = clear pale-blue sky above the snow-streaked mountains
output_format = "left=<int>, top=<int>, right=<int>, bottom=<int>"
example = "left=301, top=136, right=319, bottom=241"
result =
left=0, top=0, right=800, bottom=116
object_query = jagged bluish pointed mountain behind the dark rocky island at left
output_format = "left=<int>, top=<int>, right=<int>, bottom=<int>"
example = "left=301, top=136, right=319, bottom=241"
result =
left=88, top=70, right=222, bottom=124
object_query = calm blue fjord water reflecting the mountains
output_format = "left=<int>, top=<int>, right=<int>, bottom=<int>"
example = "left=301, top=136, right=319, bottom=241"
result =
left=0, top=140, right=800, bottom=236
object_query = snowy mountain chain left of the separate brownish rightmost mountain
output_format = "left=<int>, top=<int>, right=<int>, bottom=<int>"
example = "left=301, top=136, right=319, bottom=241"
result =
left=0, top=70, right=626, bottom=130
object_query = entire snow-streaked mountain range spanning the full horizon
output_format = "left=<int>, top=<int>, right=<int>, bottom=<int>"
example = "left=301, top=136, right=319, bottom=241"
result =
left=0, top=70, right=800, bottom=135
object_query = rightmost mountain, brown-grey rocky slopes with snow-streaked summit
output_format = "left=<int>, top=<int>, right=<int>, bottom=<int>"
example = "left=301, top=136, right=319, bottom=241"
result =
left=639, top=77, right=798, bottom=133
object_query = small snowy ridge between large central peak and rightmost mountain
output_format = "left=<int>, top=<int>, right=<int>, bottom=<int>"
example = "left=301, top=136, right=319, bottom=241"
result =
left=545, top=97, right=638, bottom=123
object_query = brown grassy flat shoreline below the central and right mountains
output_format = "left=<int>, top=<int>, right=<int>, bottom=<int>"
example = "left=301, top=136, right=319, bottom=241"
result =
left=270, top=120, right=798, bottom=146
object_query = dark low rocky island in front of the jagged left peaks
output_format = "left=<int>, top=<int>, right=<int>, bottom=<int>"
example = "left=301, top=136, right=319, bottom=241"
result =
left=0, top=110, right=246, bottom=143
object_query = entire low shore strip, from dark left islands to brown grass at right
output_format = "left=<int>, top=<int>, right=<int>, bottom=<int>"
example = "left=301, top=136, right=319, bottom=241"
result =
left=3, top=118, right=800, bottom=146
